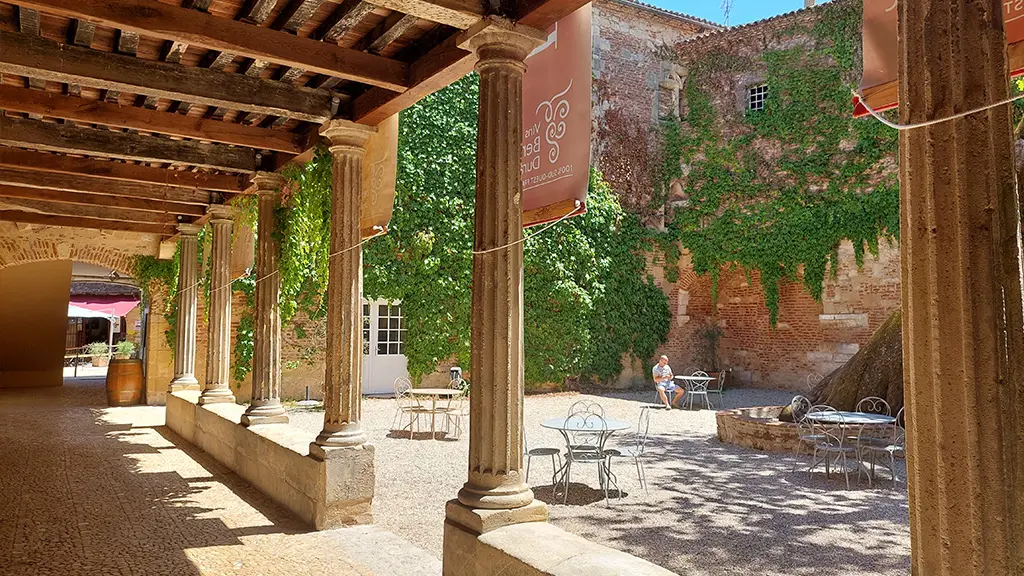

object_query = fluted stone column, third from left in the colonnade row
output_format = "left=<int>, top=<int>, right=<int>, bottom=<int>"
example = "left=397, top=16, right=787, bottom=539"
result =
left=242, top=172, right=288, bottom=425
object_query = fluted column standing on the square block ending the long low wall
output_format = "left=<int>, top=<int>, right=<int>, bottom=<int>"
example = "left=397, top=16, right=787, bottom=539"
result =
left=310, top=120, right=375, bottom=457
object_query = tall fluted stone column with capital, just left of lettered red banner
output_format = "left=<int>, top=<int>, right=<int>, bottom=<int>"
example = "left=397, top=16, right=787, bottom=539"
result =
left=444, top=17, right=547, bottom=553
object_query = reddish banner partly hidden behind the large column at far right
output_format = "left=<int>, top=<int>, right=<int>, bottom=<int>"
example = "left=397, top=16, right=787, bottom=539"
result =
left=853, top=0, right=1024, bottom=118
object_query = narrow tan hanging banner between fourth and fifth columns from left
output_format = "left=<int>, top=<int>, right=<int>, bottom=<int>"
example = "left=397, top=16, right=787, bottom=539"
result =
left=359, top=114, right=398, bottom=239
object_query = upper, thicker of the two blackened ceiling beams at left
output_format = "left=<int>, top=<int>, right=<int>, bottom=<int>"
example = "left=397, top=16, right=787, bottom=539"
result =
left=0, top=30, right=333, bottom=124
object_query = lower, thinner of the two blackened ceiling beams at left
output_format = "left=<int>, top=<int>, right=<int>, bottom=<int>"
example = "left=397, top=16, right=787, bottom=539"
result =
left=0, top=116, right=259, bottom=172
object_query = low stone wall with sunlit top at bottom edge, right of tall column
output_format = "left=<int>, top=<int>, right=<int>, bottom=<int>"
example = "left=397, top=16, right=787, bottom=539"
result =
left=443, top=510, right=673, bottom=576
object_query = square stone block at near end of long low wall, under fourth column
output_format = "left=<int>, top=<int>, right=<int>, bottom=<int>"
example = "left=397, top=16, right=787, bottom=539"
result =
left=309, top=444, right=376, bottom=530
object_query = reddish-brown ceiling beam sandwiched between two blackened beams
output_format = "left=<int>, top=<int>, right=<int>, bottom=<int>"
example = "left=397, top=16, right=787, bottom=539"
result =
left=0, top=85, right=308, bottom=154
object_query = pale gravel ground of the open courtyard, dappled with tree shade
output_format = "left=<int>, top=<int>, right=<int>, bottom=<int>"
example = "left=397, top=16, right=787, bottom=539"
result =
left=291, top=389, right=910, bottom=576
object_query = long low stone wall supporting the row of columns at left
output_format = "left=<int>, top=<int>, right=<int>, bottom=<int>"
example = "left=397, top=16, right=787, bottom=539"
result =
left=167, top=392, right=374, bottom=530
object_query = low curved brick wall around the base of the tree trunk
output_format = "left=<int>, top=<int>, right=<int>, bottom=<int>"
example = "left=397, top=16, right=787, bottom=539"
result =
left=715, top=406, right=800, bottom=454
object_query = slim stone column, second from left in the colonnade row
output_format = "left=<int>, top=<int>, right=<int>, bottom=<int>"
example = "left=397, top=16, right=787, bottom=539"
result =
left=199, top=204, right=234, bottom=404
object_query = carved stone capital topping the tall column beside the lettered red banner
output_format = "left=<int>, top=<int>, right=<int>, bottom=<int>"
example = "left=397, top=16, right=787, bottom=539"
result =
left=458, top=15, right=548, bottom=70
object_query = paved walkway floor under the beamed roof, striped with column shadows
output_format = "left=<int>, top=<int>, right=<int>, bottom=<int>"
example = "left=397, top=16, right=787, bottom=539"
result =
left=0, top=379, right=440, bottom=576
